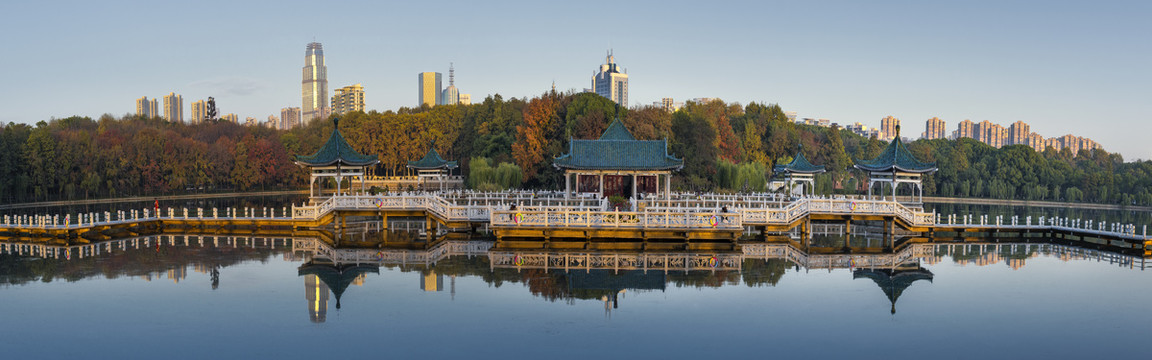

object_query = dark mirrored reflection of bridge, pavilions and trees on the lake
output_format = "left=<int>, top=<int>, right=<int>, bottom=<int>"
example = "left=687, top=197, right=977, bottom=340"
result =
left=0, top=235, right=1146, bottom=323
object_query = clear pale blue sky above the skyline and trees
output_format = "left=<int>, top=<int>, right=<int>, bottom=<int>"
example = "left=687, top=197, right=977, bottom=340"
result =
left=0, top=0, right=1152, bottom=160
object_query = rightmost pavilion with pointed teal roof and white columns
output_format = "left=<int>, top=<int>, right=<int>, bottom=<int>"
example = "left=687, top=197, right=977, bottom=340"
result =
left=854, top=125, right=937, bottom=203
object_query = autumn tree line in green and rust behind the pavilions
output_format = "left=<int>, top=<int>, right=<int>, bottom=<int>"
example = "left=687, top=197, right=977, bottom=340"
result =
left=0, top=91, right=1152, bottom=205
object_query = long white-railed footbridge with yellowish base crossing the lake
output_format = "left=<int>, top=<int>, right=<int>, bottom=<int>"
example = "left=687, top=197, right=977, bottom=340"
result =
left=0, top=192, right=1152, bottom=252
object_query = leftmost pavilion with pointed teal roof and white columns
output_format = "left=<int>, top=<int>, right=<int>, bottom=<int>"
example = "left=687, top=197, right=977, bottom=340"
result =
left=296, top=118, right=380, bottom=196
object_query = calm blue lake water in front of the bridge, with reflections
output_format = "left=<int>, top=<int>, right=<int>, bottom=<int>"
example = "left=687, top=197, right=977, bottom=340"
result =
left=0, top=231, right=1152, bottom=359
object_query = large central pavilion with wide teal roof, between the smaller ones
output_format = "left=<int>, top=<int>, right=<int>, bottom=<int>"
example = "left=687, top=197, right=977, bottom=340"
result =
left=552, top=118, right=684, bottom=198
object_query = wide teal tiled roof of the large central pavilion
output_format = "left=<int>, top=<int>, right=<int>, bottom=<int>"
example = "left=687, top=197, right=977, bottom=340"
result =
left=552, top=118, right=684, bottom=171
